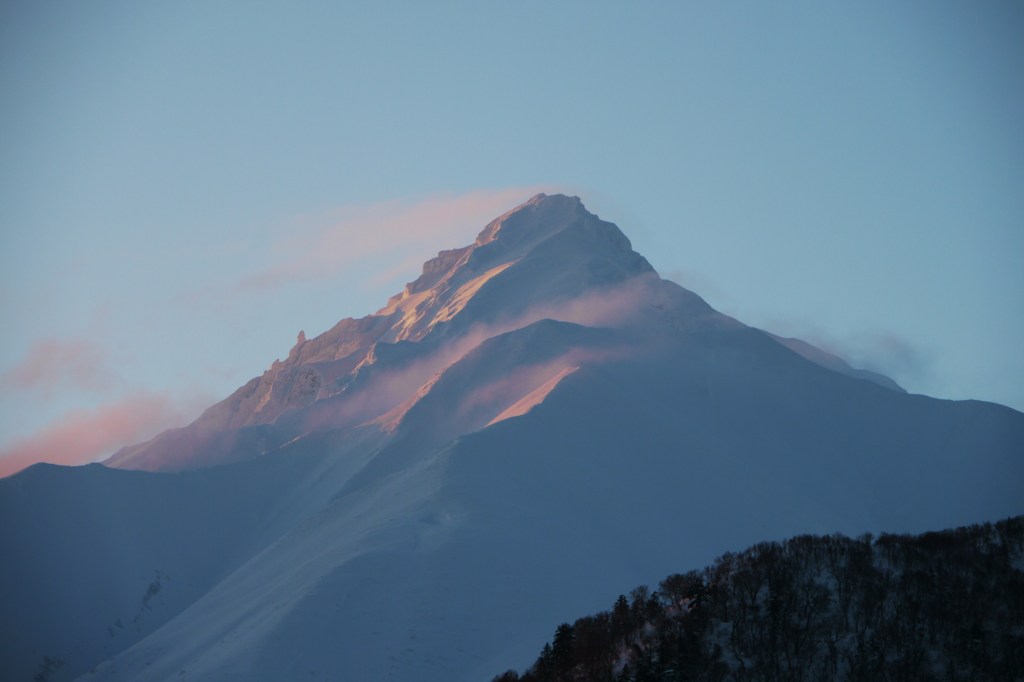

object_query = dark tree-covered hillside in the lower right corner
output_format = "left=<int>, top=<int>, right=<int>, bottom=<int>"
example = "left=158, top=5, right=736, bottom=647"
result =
left=494, top=517, right=1024, bottom=682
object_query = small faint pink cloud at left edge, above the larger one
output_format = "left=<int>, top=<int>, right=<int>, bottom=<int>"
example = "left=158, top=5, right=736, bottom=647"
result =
left=3, top=339, right=116, bottom=394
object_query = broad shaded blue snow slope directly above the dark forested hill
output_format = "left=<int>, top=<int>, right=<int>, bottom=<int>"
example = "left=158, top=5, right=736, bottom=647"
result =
left=74, top=323, right=1024, bottom=680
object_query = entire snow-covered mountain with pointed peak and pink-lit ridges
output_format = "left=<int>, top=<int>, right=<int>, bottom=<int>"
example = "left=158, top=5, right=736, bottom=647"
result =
left=0, top=195, right=1024, bottom=681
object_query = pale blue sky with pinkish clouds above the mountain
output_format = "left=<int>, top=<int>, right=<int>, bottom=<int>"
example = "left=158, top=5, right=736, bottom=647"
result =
left=0, top=2, right=1024, bottom=466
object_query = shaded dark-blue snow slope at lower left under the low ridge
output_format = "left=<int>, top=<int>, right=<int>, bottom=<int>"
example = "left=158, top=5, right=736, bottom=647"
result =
left=0, top=444, right=337, bottom=680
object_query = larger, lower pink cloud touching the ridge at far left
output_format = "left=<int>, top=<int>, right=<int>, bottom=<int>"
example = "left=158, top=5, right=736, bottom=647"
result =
left=0, top=393, right=198, bottom=477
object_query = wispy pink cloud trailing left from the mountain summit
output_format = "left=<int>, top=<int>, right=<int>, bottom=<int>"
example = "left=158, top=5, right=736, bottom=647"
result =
left=236, top=186, right=552, bottom=293
